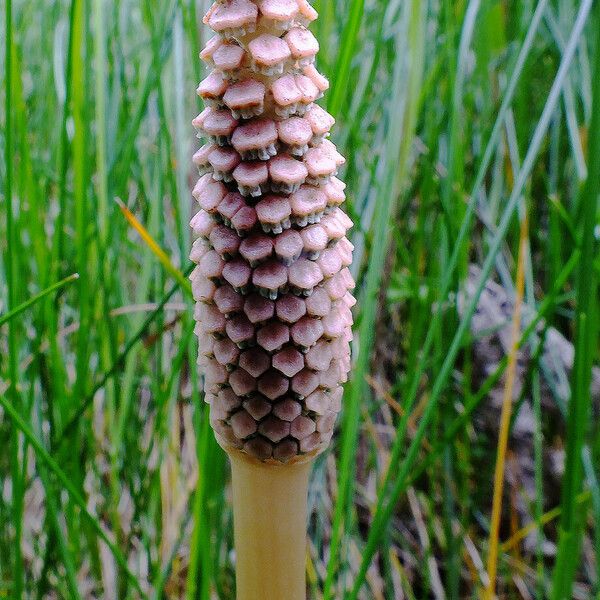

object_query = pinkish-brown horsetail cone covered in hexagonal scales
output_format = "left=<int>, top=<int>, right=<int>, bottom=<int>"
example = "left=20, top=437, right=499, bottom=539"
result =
left=190, top=0, right=355, bottom=463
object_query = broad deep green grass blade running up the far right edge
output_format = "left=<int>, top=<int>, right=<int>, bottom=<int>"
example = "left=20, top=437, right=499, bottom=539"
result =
left=551, top=3, right=600, bottom=600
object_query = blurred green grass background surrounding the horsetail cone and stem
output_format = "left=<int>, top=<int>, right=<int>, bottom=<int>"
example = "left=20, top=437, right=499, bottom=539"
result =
left=0, top=0, right=600, bottom=600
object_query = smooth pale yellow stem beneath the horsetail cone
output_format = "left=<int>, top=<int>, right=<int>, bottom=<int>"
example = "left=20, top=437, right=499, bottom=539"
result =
left=228, top=451, right=312, bottom=600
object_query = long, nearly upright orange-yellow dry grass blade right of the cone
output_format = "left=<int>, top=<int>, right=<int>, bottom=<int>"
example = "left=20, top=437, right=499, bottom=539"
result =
left=484, top=214, right=529, bottom=600
